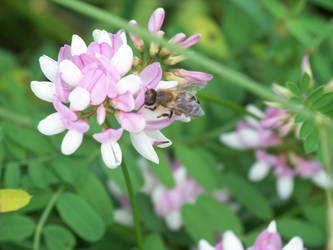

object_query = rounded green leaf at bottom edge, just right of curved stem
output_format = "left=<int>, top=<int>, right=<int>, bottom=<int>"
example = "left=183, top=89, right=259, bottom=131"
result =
left=43, top=224, right=76, bottom=250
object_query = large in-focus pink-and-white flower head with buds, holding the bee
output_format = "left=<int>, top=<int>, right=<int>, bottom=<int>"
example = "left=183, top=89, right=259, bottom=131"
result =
left=31, top=8, right=212, bottom=168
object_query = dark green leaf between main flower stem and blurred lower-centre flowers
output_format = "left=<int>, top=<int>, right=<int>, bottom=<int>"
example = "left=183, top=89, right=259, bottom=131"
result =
left=136, top=194, right=163, bottom=232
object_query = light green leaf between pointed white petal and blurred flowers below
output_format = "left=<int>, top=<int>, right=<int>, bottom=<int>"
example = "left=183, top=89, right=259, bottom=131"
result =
left=148, top=150, right=175, bottom=189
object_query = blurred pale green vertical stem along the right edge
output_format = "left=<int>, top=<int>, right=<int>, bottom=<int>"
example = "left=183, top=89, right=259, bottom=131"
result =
left=318, top=127, right=333, bottom=250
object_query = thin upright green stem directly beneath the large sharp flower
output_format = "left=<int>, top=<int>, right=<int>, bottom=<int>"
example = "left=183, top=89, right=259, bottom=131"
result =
left=121, top=159, right=143, bottom=250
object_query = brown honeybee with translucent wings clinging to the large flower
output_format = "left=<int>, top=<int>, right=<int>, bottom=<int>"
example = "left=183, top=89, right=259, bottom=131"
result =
left=144, top=83, right=206, bottom=118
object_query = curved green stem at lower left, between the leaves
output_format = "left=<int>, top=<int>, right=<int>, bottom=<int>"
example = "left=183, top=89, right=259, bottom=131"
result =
left=33, top=186, right=65, bottom=250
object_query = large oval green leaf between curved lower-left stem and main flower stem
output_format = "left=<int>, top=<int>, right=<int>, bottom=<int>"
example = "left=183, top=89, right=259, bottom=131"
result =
left=75, top=174, right=113, bottom=226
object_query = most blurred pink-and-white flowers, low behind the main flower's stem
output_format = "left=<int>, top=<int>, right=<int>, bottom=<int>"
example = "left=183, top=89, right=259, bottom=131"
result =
left=108, top=159, right=230, bottom=230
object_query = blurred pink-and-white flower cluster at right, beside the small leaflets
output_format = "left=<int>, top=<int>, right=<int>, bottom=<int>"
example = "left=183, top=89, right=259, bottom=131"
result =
left=220, top=102, right=330, bottom=199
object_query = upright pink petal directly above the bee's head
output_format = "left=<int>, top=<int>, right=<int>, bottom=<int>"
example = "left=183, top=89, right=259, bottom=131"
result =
left=140, top=62, right=162, bottom=89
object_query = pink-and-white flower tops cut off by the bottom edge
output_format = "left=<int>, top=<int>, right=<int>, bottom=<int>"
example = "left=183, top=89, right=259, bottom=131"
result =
left=199, top=221, right=305, bottom=250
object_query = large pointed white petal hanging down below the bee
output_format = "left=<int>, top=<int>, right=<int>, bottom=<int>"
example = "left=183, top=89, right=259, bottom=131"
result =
left=130, top=132, right=159, bottom=164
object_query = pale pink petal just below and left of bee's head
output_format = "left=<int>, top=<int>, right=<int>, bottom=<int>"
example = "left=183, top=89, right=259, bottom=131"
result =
left=118, top=111, right=146, bottom=132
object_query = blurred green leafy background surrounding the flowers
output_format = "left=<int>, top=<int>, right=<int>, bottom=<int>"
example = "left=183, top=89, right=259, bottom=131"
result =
left=0, top=0, right=333, bottom=250
